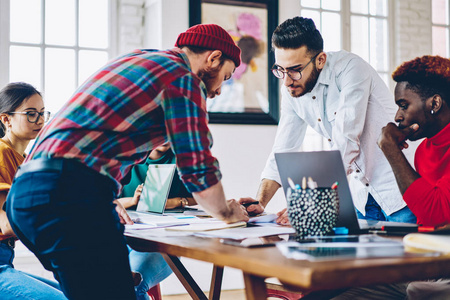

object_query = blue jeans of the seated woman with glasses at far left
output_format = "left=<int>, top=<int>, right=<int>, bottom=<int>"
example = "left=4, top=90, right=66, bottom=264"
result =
left=0, top=244, right=67, bottom=300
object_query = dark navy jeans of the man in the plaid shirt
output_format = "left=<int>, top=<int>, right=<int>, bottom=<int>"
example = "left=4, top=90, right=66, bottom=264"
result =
left=7, top=160, right=136, bottom=300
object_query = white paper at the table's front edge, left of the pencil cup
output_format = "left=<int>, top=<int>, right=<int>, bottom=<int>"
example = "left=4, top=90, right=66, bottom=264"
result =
left=195, top=226, right=295, bottom=240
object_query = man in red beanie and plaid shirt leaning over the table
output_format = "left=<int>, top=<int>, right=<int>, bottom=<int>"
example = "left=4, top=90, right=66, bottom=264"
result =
left=7, top=24, right=248, bottom=300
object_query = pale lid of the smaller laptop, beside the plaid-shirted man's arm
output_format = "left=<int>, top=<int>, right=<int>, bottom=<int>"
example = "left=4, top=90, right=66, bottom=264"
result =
left=136, top=164, right=176, bottom=214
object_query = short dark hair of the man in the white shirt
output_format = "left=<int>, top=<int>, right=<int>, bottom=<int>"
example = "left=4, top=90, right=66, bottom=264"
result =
left=272, top=17, right=323, bottom=54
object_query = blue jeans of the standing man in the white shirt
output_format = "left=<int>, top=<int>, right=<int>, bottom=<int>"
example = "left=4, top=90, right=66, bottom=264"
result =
left=356, top=194, right=417, bottom=223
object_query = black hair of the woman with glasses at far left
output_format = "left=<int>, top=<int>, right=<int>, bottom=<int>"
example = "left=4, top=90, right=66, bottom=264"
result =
left=0, top=82, right=42, bottom=137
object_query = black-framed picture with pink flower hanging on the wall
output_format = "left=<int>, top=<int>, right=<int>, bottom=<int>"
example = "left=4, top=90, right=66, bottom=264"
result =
left=189, top=0, right=279, bottom=124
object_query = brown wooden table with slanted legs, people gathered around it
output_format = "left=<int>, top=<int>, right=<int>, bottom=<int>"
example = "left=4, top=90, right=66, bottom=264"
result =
left=125, top=230, right=450, bottom=300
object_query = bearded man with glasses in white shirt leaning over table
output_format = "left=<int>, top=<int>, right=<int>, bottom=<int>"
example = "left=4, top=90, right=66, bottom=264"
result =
left=240, top=17, right=416, bottom=224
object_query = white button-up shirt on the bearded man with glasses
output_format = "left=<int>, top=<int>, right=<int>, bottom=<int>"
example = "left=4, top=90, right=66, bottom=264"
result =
left=261, top=51, right=414, bottom=215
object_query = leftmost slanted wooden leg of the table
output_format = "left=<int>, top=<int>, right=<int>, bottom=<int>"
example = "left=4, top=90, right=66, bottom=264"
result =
left=161, top=253, right=208, bottom=300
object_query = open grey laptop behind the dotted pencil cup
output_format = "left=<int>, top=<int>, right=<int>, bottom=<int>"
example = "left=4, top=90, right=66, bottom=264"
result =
left=275, top=150, right=417, bottom=233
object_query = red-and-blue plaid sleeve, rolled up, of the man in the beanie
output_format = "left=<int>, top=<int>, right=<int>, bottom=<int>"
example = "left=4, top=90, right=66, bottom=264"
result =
left=161, top=75, right=222, bottom=193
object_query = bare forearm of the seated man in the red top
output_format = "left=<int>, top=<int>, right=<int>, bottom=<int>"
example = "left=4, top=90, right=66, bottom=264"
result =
left=381, top=145, right=420, bottom=195
